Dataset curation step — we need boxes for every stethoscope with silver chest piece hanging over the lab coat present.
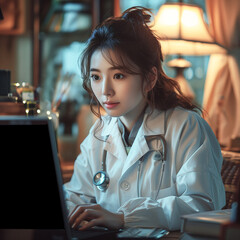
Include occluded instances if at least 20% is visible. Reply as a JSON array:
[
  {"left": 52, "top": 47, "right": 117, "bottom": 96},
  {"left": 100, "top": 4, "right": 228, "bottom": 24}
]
[{"left": 93, "top": 135, "right": 166, "bottom": 199}]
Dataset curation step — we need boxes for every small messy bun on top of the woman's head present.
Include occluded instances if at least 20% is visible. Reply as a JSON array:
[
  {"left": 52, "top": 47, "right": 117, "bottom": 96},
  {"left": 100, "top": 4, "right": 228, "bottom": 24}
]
[{"left": 122, "top": 7, "right": 152, "bottom": 25}]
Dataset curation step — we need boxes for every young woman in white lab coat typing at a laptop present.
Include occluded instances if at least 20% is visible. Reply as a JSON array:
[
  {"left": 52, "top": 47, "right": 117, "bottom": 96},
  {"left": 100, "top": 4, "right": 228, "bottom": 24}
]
[{"left": 64, "top": 7, "right": 225, "bottom": 230}]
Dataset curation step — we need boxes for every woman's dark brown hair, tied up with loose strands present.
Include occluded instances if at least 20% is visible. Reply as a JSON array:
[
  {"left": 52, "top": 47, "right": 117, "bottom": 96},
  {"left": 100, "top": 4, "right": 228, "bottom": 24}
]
[{"left": 81, "top": 7, "right": 201, "bottom": 117}]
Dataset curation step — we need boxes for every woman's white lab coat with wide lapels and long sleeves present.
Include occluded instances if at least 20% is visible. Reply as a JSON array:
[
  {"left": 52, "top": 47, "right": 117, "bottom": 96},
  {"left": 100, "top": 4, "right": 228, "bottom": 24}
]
[{"left": 64, "top": 108, "right": 225, "bottom": 230}]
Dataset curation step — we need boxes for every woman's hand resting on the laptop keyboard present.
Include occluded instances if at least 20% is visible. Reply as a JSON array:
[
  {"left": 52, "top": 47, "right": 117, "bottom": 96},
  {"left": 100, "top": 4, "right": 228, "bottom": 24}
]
[{"left": 69, "top": 204, "right": 124, "bottom": 230}]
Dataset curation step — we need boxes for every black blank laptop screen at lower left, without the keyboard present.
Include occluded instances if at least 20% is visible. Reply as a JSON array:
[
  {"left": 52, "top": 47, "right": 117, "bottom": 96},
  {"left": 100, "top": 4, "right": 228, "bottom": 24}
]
[{"left": 0, "top": 118, "right": 64, "bottom": 229}]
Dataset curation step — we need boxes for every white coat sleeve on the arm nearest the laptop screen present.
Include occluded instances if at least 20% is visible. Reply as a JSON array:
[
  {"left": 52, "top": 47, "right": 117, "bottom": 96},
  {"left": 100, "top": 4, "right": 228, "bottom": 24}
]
[{"left": 63, "top": 137, "right": 96, "bottom": 212}]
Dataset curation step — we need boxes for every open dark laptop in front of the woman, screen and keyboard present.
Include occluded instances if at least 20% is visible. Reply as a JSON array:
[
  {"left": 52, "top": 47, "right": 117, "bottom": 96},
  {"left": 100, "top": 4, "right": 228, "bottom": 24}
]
[{"left": 0, "top": 116, "right": 116, "bottom": 240}]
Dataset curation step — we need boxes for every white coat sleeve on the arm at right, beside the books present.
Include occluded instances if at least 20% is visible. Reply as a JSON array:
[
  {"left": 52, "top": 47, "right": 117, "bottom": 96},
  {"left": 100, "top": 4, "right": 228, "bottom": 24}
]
[{"left": 118, "top": 112, "right": 225, "bottom": 230}]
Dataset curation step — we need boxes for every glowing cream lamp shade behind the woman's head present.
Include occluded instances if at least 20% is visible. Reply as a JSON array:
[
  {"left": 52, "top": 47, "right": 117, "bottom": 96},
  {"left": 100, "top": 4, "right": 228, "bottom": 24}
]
[{"left": 152, "top": 3, "right": 226, "bottom": 55}]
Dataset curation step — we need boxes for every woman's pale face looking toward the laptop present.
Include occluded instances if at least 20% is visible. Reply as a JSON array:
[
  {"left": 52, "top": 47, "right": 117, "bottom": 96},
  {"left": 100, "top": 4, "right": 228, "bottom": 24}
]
[{"left": 90, "top": 50, "right": 146, "bottom": 130}]
